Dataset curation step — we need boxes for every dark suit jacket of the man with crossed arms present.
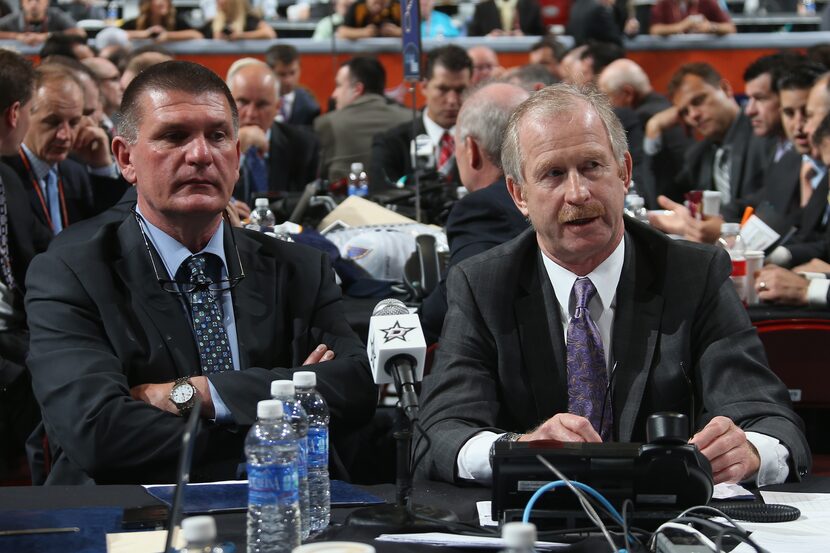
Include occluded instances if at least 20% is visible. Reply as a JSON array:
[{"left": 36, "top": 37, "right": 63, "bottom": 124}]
[{"left": 26, "top": 213, "right": 377, "bottom": 484}]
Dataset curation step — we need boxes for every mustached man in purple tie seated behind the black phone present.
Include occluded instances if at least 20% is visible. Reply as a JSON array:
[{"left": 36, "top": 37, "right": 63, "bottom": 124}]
[{"left": 415, "top": 84, "right": 810, "bottom": 485}]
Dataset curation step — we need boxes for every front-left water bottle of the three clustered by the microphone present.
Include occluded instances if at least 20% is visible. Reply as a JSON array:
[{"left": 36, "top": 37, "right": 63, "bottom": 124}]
[{"left": 245, "top": 399, "right": 301, "bottom": 553}]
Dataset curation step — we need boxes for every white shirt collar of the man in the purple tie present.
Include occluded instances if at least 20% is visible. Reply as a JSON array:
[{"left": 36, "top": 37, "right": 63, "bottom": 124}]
[{"left": 542, "top": 238, "right": 625, "bottom": 316}]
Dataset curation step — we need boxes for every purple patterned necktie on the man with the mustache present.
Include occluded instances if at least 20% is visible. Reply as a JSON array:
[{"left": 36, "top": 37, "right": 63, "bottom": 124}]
[{"left": 567, "top": 278, "right": 613, "bottom": 441}]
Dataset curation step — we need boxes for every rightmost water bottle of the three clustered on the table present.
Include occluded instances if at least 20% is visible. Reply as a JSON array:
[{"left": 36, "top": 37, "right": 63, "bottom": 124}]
[{"left": 294, "top": 371, "right": 331, "bottom": 532}]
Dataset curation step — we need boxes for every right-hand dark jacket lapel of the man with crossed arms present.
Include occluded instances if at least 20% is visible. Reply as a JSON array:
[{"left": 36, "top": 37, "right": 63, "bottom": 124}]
[{"left": 229, "top": 225, "right": 278, "bottom": 369}]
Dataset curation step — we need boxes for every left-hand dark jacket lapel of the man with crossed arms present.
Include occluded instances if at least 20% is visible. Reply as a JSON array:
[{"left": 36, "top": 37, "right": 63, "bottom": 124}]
[{"left": 114, "top": 214, "right": 201, "bottom": 376}]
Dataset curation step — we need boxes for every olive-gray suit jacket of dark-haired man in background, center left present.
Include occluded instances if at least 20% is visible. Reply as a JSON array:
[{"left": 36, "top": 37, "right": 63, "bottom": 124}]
[{"left": 314, "top": 94, "right": 412, "bottom": 181}]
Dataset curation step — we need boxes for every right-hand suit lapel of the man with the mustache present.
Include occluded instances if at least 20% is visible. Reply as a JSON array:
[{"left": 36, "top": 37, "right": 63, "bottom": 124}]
[{"left": 611, "top": 232, "right": 663, "bottom": 442}]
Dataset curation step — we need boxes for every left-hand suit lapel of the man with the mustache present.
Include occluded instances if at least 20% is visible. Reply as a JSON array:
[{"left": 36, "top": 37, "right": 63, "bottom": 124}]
[{"left": 514, "top": 235, "right": 568, "bottom": 420}]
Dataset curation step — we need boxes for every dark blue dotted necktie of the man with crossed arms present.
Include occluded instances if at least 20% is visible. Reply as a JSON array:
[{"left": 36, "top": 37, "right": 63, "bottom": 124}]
[{"left": 179, "top": 254, "right": 233, "bottom": 374}]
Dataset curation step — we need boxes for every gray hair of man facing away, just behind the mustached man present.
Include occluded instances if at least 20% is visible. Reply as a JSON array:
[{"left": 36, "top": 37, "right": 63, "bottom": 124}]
[{"left": 455, "top": 82, "right": 529, "bottom": 169}]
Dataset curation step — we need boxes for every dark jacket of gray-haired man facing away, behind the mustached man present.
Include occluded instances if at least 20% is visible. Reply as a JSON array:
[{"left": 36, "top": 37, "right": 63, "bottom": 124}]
[{"left": 421, "top": 177, "right": 528, "bottom": 343}]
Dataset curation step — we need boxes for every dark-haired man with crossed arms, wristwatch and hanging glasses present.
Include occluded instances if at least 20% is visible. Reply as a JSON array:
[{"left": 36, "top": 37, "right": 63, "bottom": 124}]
[{"left": 26, "top": 61, "right": 377, "bottom": 484}]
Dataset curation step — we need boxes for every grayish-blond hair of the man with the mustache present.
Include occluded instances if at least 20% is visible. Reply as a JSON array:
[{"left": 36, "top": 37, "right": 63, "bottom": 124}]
[{"left": 501, "top": 83, "right": 628, "bottom": 185}]
